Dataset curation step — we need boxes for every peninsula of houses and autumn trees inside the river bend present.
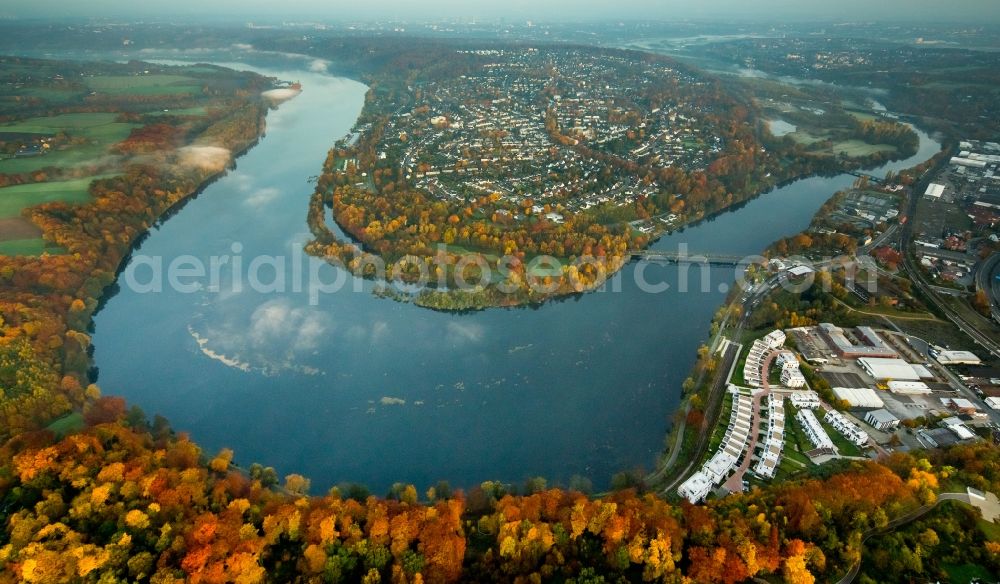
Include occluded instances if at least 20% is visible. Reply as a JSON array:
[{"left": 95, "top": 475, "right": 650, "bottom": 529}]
[{"left": 296, "top": 38, "right": 919, "bottom": 311}]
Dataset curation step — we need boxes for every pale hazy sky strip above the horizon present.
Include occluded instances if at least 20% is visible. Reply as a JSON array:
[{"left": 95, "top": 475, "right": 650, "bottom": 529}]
[{"left": 7, "top": 0, "right": 1000, "bottom": 23}]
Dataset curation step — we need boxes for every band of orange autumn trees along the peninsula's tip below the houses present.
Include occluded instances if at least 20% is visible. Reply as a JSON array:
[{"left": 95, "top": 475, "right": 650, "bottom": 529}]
[{"left": 306, "top": 151, "right": 642, "bottom": 310}]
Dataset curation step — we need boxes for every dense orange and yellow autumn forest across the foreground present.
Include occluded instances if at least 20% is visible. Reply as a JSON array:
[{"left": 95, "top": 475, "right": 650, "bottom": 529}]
[{"left": 0, "top": 398, "right": 984, "bottom": 583}]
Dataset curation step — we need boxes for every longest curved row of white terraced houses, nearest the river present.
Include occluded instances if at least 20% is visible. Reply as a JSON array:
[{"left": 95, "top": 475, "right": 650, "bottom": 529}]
[{"left": 677, "top": 385, "right": 756, "bottom": 503}]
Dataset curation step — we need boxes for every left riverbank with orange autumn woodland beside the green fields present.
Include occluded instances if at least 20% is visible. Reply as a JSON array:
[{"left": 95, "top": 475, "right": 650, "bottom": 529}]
[{"left": 0, "top": 60, "right": 282, "bottom": 436}]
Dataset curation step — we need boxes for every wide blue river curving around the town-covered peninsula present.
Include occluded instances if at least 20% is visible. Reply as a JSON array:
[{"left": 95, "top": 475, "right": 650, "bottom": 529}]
[{"left": 93, "top": 58, "right": 940, "bottom": 492}]
